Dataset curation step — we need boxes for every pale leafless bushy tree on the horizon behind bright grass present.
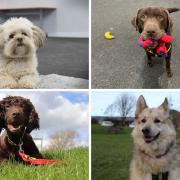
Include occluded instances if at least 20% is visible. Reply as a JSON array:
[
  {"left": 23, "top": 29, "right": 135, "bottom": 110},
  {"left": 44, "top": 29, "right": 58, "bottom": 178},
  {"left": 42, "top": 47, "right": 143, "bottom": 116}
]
[{"left": 48, "top": 130, "right": 78, "bottom": 150}]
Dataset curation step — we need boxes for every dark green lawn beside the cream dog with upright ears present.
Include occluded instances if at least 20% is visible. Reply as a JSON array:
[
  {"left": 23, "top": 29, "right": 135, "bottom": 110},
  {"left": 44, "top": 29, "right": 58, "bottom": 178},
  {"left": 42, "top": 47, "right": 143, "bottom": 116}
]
[{"left": 92, "top": 125, "right": 180, "bottom": 180}]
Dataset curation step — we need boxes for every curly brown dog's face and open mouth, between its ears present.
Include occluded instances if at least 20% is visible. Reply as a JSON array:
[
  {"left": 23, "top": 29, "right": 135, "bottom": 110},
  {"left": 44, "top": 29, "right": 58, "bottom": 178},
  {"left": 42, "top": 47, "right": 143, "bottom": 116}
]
[{"left": 5, "top": 106, "right": 28, "bottom": 134}]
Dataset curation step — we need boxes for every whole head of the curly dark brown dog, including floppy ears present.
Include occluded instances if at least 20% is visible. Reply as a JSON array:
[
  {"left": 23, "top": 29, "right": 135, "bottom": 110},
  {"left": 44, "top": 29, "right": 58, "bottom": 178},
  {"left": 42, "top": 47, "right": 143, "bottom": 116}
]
[{"left": 0, "top": 96, "right": 39, "bottom": 134}]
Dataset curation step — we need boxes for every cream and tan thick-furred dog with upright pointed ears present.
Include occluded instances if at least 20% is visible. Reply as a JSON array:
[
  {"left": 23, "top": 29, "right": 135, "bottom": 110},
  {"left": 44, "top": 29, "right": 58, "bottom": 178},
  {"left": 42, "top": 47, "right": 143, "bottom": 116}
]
[{"left": 130, "top": 96, "right": 180, "bottom": 180}]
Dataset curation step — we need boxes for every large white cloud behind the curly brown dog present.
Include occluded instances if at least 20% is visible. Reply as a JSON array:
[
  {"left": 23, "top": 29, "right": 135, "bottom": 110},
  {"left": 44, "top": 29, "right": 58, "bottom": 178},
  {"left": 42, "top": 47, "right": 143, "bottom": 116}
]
[{"left": 0, "top": 91, "right": 89, "bottom": 147}]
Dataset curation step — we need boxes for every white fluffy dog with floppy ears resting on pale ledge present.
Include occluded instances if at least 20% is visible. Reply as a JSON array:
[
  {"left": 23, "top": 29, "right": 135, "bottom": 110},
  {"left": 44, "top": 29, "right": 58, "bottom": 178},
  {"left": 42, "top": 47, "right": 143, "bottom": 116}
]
[{"left": 0, "top": 17, "right": 45, "bottom": 88}]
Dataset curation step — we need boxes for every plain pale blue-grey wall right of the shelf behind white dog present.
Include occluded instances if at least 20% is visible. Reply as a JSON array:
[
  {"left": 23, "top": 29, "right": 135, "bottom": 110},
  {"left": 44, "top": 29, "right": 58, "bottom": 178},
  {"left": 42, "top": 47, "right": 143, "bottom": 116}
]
[{"left": 44, "top": 0, "right": 89, "bottom": 37}]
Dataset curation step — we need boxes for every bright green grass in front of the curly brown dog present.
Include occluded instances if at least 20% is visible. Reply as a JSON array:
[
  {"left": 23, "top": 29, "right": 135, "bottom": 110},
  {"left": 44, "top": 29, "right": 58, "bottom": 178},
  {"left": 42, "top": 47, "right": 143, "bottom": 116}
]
[{"left": 0, "top": 148, "right": 88, "bottom": 180}]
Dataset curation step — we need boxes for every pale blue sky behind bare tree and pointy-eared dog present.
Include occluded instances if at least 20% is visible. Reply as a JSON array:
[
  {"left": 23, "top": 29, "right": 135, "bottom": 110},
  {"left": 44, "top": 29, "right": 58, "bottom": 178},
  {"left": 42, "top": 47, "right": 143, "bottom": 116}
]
[{"left": 91, "top": 90, "right": 180, "bottom": 116}]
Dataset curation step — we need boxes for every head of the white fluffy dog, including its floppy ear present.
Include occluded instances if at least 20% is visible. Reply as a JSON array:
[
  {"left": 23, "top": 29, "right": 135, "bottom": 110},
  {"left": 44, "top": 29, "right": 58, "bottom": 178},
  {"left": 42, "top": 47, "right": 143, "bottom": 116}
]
[{"left": 0, "top": 18, "right": 45, "bottom": 58}]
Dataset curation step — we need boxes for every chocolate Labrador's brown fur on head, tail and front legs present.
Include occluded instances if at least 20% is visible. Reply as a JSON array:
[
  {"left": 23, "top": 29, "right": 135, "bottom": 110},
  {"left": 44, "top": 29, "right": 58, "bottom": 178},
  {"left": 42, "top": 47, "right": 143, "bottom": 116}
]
[{"left": 131, "top": 7, "right": 179, "bottom": 77}]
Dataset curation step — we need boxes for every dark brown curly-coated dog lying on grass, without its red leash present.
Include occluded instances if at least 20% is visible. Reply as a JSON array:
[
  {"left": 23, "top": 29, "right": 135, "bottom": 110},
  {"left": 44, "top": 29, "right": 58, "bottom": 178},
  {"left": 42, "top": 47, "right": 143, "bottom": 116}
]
[{"left": 0, "top": 96, "right": 42, "bottom": 162}]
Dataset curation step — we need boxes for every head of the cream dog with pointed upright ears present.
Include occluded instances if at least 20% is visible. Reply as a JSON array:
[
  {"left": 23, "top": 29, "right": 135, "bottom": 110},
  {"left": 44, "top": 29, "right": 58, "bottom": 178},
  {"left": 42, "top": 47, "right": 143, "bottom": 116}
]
[{"left": 132, "top": 96, "right": 176, "bottom": 144}]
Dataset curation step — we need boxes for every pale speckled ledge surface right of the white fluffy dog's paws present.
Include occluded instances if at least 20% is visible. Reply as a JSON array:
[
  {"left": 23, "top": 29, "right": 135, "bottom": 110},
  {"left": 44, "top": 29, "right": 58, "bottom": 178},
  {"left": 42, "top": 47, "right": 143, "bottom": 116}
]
[{"left": 37, "top": 74, "right": 89, "bottom": 89}]
